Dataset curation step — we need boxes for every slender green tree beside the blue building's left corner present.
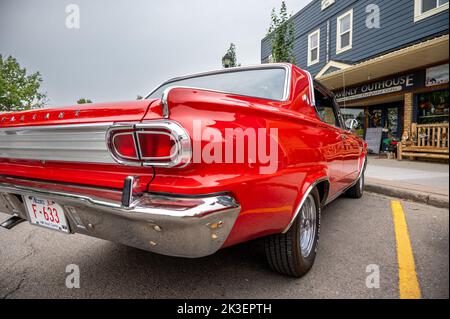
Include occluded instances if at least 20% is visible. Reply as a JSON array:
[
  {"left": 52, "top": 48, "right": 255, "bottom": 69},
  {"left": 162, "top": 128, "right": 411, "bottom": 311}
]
[{"left": 267, "top": 1, "right": 295, "bottom": 64}]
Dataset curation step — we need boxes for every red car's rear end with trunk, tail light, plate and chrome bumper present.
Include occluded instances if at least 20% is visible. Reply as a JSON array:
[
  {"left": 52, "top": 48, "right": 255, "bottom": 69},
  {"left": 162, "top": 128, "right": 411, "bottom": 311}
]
[{"left": 0, "top": 100, "right": 240, "bottom": 257}]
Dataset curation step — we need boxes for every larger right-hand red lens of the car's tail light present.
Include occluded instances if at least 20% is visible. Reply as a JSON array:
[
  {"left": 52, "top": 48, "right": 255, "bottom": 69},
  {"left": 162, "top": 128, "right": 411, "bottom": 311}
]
[{"left": 137, "top": 131, "right": 176, "bottom": 160}]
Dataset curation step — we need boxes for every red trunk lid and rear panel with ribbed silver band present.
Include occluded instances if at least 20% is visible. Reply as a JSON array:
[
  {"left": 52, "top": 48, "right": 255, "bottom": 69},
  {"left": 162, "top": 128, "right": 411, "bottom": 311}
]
[{"left": 0, "top": 100, "right": 162, "bottom": 189}]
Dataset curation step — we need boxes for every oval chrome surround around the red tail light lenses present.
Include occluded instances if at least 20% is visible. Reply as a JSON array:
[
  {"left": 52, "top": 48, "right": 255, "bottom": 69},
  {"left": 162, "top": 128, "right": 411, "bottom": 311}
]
[{"left": 106, "top": 120, "right": 192, "bottom": 168}]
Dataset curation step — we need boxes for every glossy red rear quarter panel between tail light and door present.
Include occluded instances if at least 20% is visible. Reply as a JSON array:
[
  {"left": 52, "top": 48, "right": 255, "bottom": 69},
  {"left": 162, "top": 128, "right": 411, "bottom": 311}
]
[{"left": 149, "top": 89, "right": 337, "bottom": 246}]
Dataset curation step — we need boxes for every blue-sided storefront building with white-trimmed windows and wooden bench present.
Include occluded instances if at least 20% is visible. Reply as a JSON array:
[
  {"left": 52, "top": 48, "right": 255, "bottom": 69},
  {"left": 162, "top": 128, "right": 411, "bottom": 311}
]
[{"left": 261, "top": 0, "right": 449, "bottom": 158}]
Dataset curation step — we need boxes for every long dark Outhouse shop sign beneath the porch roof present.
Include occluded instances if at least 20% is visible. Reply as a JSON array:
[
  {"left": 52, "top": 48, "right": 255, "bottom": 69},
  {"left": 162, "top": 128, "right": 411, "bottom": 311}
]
[{"left": 336, "top": 73, "right": 416, "bottom": 102}]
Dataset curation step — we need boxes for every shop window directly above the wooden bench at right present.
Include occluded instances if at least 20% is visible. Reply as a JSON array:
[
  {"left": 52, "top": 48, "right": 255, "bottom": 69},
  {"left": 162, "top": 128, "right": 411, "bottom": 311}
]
[{"left": 417, "top": 90, "right": 449, "bottom": 124}]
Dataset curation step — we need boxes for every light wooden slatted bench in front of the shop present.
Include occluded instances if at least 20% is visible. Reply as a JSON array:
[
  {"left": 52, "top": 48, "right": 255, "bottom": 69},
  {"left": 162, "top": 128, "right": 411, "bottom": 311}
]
[{"left": 397, "top": 123, "right": 449, "bottom": 161}]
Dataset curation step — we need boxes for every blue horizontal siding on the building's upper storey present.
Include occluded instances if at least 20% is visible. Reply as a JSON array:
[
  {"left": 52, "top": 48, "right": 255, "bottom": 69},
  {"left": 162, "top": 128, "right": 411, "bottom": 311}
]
[{"left": 261, "top": 0, "right": 449, "bottom": 75}]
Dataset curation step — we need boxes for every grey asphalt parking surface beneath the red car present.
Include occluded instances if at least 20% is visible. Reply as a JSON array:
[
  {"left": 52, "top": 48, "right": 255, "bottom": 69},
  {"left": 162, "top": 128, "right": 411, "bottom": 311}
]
[{"left": 0, "top": 193, "right": 449, "bottom": 298}]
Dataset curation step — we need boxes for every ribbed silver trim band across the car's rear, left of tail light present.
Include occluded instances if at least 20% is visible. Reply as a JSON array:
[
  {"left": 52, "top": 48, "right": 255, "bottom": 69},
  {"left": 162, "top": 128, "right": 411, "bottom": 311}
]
[{"left": 0, "top": 123, "right": 115, "bottom": 164}]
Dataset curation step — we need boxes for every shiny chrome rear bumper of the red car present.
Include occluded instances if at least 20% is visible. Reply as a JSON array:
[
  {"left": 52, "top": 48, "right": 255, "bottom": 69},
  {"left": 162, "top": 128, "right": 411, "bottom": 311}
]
[{"left": 0, "top": 176, "right": 240, "bottom": 258}]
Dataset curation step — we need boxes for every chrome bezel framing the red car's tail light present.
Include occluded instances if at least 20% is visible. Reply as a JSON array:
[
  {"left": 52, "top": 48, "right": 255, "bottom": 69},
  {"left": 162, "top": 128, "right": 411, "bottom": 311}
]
[{"left": 106, "top": 120, "right": 192, "bottom": 168}]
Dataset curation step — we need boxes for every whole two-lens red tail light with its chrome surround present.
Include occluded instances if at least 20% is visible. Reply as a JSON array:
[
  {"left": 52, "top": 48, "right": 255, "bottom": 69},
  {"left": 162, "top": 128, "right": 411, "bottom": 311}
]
[{"left": 107, "top": 120, "right": 192, "bottom": 167}]
